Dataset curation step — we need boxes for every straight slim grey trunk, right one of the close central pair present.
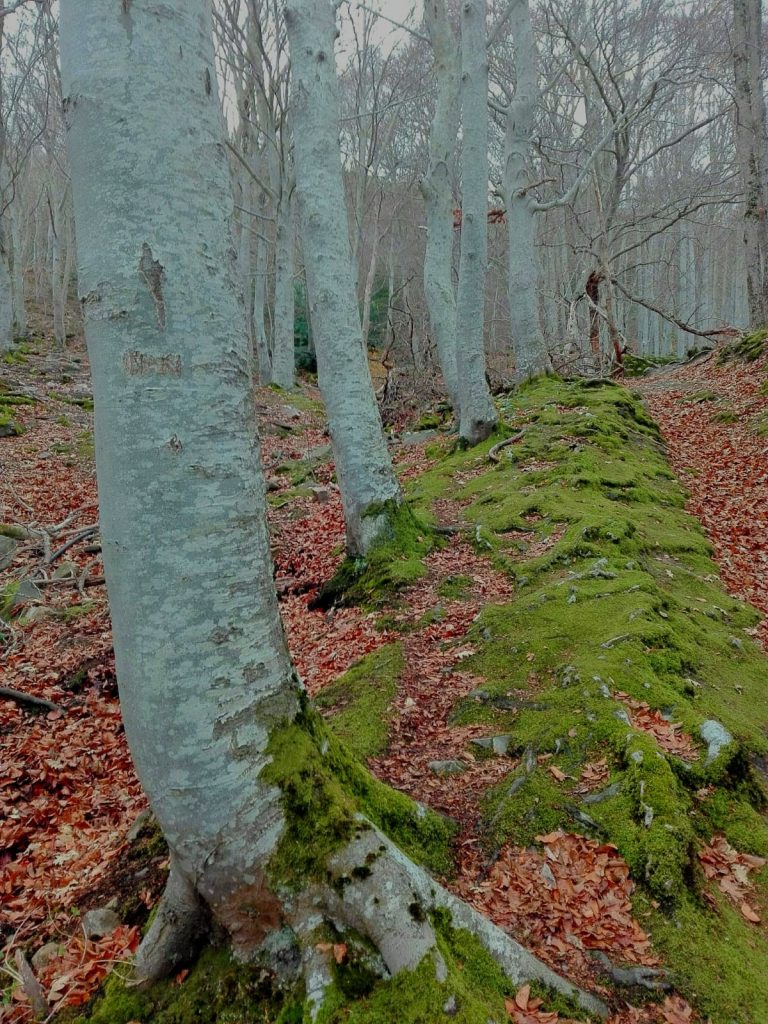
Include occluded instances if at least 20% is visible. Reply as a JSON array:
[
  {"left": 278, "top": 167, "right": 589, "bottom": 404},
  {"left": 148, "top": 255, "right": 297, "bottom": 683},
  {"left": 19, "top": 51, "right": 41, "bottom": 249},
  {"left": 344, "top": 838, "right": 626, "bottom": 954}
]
[{"left": 456, "top": 0, "right": 499, "bottom": 444}]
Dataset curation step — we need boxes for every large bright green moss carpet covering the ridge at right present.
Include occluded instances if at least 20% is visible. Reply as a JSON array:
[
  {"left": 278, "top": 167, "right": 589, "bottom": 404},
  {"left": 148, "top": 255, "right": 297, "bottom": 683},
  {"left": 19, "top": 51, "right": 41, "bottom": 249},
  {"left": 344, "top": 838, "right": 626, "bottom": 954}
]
[{"left": 399, "top": 379, "right": 768, "bottom": 905}]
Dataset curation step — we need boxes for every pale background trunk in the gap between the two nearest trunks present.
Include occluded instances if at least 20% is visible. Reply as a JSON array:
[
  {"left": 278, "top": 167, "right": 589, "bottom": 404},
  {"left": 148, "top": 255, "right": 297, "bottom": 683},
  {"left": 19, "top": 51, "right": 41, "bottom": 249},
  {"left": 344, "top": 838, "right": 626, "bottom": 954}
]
[{"left": 271, "top": 180, "right": 296, "bottom": 388}]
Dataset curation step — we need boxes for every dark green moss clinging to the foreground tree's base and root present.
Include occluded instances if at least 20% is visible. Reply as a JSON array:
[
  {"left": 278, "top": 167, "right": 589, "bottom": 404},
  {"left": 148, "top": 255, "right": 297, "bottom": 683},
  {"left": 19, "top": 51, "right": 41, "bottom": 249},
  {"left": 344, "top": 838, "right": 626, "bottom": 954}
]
[{"left": 263, "top": 709, "right": 455, "bottom": 888}]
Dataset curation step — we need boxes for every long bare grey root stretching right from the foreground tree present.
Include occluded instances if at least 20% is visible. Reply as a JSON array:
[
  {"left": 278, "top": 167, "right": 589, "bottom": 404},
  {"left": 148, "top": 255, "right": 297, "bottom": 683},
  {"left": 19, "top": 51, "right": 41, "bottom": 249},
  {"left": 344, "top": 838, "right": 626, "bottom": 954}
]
[{"left": 328, "top": 819, "right": 608, "bottom": 1017}]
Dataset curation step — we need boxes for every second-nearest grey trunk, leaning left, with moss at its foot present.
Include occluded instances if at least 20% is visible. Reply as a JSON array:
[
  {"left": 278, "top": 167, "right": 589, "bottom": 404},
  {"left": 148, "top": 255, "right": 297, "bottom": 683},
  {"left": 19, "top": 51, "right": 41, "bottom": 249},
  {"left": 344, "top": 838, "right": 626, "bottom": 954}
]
[{"left": 286, "top": 0, "right": 401, "bottom": 555}]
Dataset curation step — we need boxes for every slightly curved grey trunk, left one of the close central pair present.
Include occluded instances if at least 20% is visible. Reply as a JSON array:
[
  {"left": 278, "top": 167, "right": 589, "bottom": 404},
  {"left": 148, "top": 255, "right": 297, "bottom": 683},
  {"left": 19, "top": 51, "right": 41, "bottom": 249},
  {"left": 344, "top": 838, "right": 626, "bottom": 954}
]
[{"left": 420, "top": 0, "right": 461, "bottom": 412}]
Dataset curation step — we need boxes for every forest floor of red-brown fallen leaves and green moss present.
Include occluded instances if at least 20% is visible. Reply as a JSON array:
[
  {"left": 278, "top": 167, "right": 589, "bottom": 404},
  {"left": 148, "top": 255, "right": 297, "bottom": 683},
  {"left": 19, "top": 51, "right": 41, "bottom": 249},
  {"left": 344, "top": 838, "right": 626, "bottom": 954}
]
[{"left": 0, "top": 327, "right": 768, "bottom": 1024}]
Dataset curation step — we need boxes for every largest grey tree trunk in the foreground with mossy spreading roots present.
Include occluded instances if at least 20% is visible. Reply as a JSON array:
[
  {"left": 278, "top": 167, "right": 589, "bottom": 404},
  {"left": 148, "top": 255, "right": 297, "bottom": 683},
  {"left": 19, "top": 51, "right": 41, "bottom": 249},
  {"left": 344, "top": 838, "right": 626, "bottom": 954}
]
[{"left": 61, "top": 0, "right": 599, "bottom": 1011}]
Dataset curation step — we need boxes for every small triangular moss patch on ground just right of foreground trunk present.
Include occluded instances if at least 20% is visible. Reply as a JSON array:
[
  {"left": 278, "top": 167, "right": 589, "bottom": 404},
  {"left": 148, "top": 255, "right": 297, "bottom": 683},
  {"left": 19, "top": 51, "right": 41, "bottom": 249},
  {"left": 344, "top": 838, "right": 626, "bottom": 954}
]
[{"left": 314, "top": 643, "right": 404, "bottom": 761}]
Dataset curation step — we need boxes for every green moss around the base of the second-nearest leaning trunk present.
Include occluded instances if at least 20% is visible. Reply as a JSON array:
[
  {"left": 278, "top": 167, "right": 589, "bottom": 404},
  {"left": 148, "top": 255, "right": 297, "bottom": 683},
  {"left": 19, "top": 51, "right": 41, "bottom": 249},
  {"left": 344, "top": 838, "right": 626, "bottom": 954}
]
[{"left": 310, "top": 502, "right": 439, "bottom": 608}]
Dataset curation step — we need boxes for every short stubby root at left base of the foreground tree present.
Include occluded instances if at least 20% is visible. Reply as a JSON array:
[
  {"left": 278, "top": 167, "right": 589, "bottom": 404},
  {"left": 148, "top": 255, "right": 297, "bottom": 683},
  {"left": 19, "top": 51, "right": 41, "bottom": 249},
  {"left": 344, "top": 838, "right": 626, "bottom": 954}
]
[{"left": 134, "top": 858, "right": 209, "bottom": 988}]
